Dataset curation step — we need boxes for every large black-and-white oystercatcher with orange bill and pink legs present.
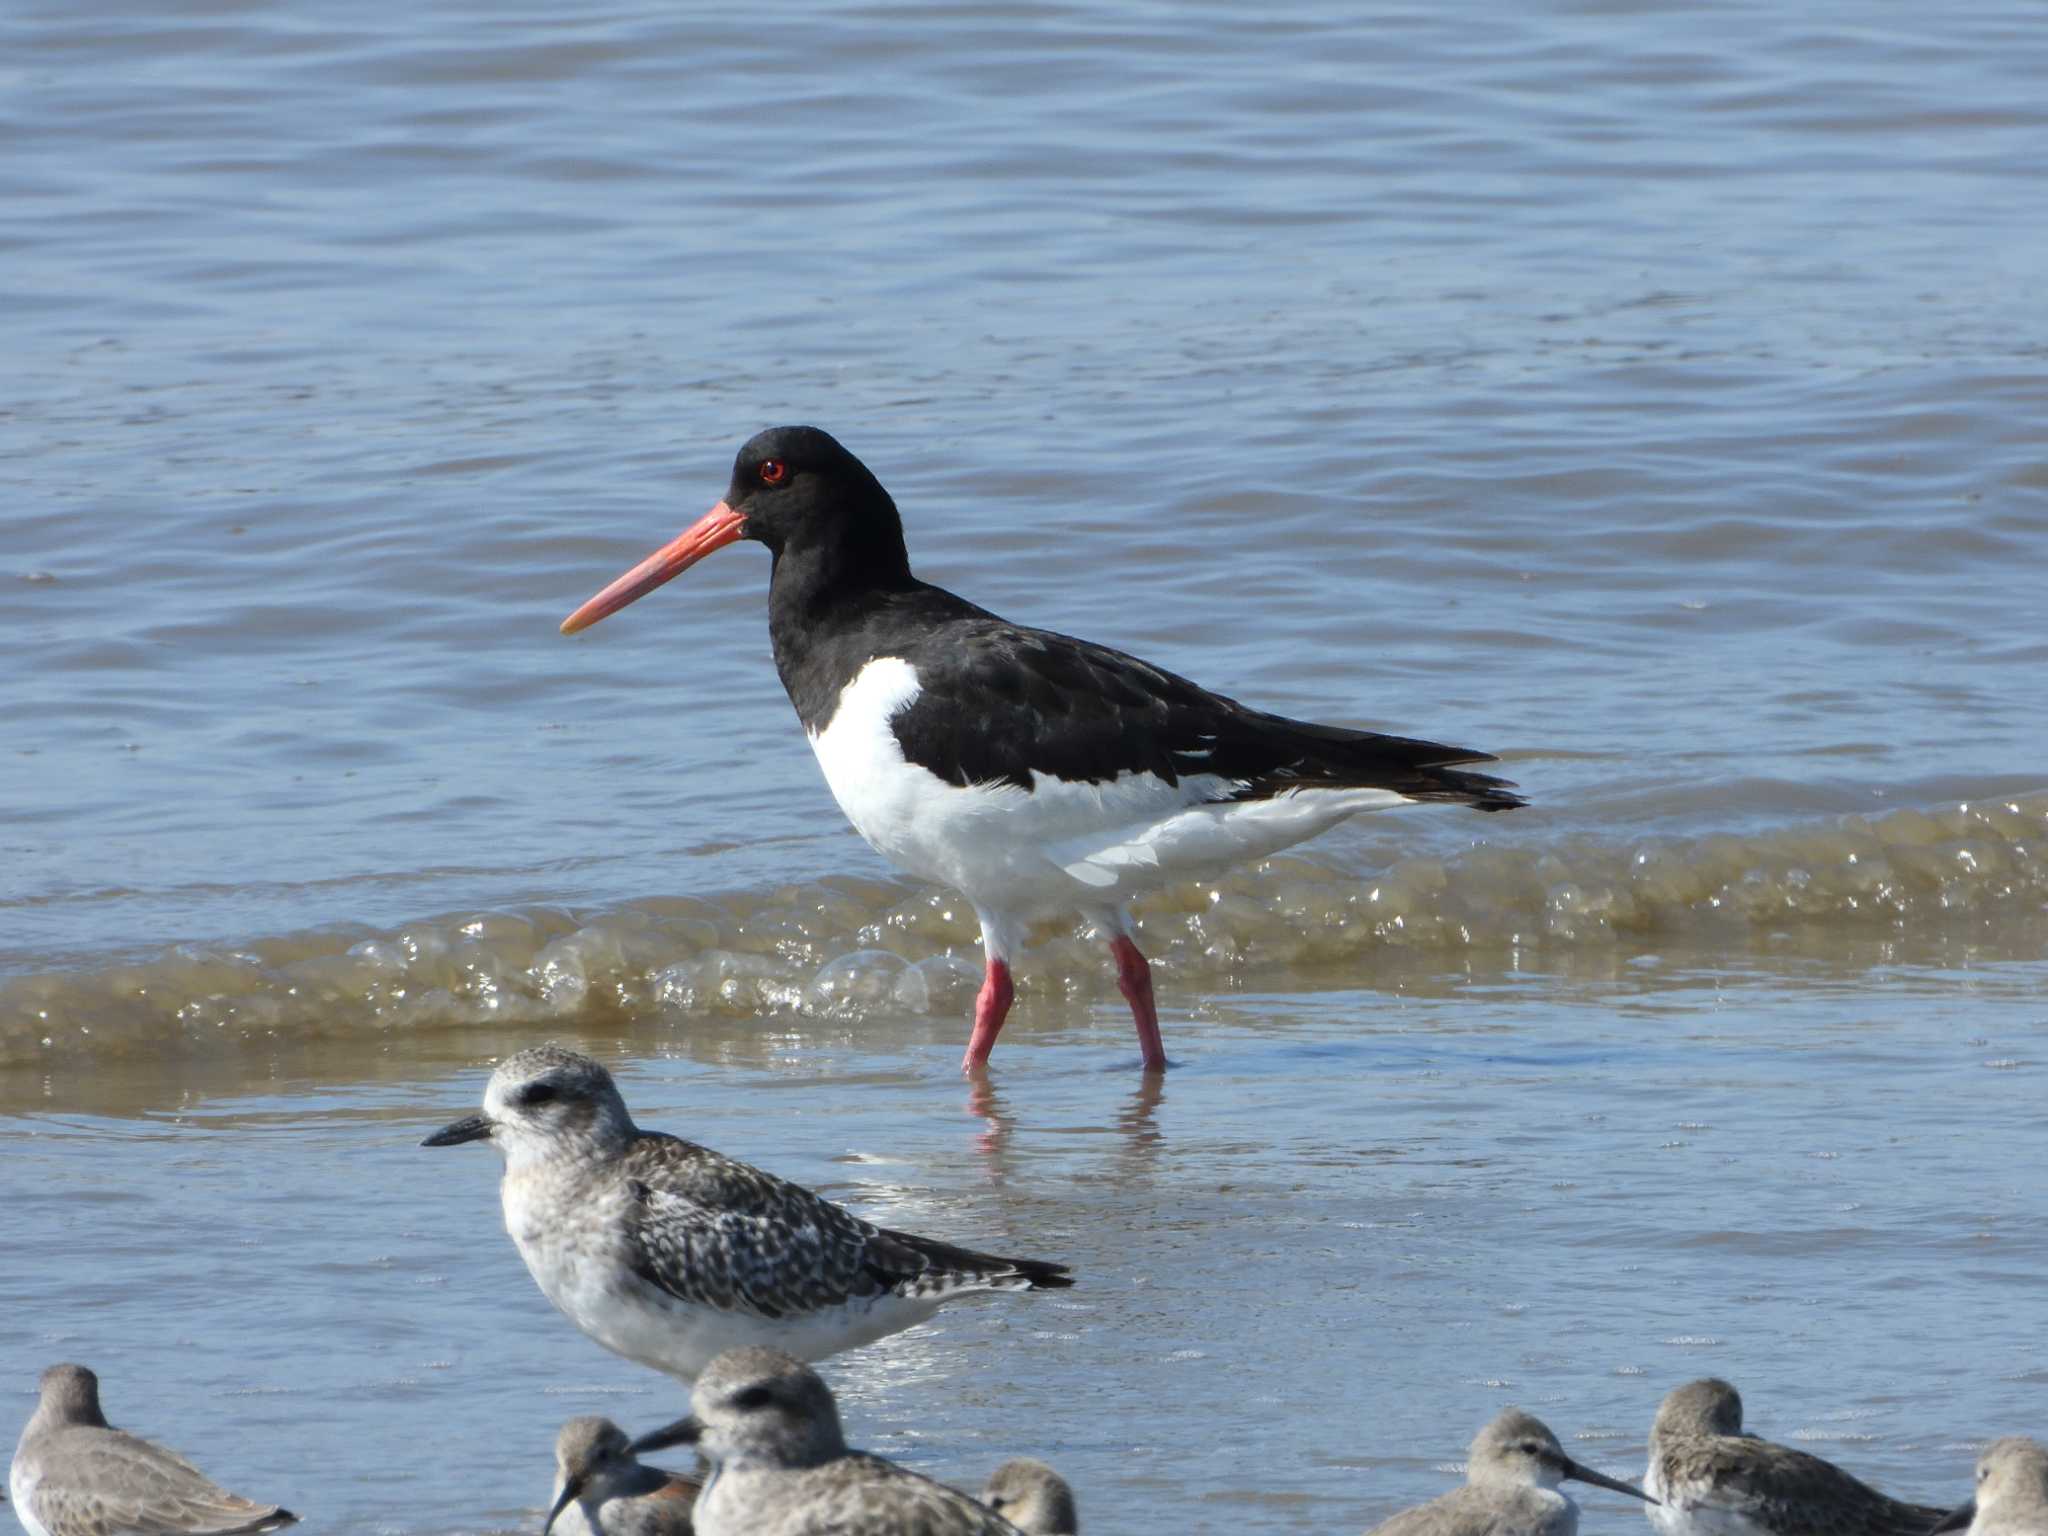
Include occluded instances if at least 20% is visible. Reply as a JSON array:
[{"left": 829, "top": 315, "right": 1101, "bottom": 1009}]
[{"left": 561, "top": 426, "right": 1526, "bottom": 1073}]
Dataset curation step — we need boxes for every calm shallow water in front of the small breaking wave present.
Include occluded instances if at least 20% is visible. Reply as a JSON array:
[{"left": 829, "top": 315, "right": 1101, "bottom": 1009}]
[{"left": 0, "top": 974, "right": 2048, "bottom": 1532}]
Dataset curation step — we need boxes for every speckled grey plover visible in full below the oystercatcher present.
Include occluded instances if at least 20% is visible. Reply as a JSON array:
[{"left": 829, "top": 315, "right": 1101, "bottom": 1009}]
[{"left": 424, "top": 1044, "right": 1073, "bottom": 1380}]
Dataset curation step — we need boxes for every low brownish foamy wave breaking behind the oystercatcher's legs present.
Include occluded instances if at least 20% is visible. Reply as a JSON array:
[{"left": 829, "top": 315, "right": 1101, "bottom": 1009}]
[{"left": 0, "top": 793, "right": 2048, "bottom": 1065}]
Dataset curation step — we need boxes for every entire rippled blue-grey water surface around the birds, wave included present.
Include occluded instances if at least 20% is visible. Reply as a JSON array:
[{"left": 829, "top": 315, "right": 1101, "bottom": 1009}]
[{"left": 0, "top": 0, "right": 2048, "bottom": 1534}]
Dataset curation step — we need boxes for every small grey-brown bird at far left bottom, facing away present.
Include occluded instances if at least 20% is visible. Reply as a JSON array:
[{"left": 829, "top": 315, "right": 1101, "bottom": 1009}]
[{"left": 8, "top": 1366, "right": 299, "bottom": 1536}]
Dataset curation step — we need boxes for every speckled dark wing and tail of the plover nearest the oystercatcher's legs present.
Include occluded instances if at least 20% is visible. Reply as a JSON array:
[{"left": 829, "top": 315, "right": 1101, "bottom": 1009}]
[{"left": 621, "top": 1133, "right": 1073, "bottom": 1317}]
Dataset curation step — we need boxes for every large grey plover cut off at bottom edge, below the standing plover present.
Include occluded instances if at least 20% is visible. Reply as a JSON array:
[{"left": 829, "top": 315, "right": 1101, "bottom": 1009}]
[{"left": 633, "top": 1348, "right": 1020, "bottom": 1536}]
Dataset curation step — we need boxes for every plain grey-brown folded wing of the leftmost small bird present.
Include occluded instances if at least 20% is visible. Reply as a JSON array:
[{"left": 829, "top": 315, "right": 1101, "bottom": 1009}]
[{"left": 35, "top": 1425, "right": 297, "bottom": 1536}]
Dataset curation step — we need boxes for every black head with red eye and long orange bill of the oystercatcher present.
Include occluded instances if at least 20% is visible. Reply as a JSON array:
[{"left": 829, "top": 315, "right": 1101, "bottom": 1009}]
[{"left": 561, "top": 426, "right": 909, "bottom": 635}]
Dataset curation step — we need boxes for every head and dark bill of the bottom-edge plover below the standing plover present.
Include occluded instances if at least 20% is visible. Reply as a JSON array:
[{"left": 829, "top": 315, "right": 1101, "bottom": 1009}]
[{"left": 633, "top": 1346, "right": 846, "bottom": 1468}]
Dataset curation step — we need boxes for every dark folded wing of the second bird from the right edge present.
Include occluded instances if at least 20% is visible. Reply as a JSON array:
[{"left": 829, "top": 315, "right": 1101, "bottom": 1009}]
[{"left": 1659, "top": 1436, "right": 1948, "bottom": 1536}]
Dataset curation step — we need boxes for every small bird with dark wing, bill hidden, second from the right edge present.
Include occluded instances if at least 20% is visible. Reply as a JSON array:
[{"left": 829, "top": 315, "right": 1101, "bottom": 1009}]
[{"left": 1642, "top": 1376, "right": 1948, "bottom": 1536}]
